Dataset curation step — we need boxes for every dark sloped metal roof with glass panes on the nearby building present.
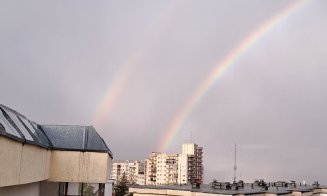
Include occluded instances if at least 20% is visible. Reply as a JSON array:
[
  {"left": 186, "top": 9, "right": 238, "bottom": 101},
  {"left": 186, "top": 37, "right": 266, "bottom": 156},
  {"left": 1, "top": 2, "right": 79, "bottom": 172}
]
[{"left": 0, "top": 104, "right": 112, "bottom": 157}]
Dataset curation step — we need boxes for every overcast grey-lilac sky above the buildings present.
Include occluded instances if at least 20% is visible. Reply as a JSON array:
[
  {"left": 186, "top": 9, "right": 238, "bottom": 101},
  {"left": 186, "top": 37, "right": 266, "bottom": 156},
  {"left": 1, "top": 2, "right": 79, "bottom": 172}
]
[{"left": 0, "top": 0, "right": 327, "bottom": 184}]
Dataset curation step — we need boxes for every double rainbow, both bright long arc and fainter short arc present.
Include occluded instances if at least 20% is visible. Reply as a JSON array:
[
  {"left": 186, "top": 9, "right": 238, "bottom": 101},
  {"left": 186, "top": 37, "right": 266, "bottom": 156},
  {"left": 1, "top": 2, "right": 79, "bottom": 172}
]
[{"left": 93, "top": 0, "right": 312, "bottom": 152}]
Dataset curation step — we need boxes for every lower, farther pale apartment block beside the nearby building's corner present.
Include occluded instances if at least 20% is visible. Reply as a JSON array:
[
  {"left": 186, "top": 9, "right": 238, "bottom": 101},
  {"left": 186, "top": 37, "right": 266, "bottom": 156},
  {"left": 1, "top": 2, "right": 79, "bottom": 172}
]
[{"left": 111, "top": 160, "right": 145, "bottom": 185}]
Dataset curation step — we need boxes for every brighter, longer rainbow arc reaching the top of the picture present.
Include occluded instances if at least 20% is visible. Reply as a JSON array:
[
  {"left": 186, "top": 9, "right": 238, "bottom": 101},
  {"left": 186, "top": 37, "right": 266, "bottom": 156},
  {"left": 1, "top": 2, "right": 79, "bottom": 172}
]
[{"left": 159, "top": 0, "right": 308, "bottom": 152}]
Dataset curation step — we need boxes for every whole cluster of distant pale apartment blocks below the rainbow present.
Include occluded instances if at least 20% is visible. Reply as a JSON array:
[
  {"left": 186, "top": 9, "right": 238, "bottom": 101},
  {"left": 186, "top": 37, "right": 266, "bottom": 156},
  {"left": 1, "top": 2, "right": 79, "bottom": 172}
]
[{"left": 110, "top": 143, "right": 204, "bottom": 185}]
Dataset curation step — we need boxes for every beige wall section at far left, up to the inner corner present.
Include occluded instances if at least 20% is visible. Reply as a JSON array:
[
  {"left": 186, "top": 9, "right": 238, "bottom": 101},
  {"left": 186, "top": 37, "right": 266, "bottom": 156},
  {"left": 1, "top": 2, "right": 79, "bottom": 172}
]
[{"left": 0, "top": 136, "right": 51, "bottom": 187}]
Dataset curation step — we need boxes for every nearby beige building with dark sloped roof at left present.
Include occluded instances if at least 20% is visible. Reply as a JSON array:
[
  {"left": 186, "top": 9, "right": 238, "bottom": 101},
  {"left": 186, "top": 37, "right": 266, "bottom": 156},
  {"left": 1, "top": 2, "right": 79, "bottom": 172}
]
[{"left": 0, "top": 105, "right": 113, "bottom": 196}]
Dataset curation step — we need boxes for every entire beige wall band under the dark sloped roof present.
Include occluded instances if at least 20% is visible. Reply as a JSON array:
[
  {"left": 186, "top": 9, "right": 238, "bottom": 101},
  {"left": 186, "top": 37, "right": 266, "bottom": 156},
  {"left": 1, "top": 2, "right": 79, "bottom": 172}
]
[{"left": 0, "top": 136, "right": 112, "bottom": 187}]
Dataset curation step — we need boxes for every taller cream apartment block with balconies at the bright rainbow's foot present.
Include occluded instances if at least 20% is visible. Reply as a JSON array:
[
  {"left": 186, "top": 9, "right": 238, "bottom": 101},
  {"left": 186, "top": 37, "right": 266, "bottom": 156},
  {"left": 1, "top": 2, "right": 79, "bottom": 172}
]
[{"left": 145, "top": 143, "right": 203, "bottom": 185}]
